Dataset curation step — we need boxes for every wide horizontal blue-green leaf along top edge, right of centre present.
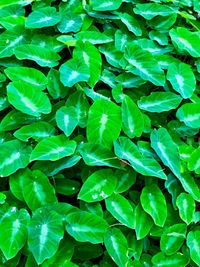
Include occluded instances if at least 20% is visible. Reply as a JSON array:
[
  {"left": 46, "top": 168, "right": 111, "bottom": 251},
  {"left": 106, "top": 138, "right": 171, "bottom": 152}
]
[{"left": 134, "top": 3, "right": 177, "bottom": 20}]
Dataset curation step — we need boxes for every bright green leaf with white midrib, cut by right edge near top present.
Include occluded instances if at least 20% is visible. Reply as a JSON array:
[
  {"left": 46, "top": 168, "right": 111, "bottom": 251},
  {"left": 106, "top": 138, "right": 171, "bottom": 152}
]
[{"left": 169, "top": 27, "right": 200, "bottom": 57}]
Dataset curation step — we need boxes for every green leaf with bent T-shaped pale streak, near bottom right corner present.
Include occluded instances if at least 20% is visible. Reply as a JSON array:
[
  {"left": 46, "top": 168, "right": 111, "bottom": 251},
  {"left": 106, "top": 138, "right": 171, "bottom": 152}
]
[{"left": 160, "top": 223, "right": 187, "bottom": 255}]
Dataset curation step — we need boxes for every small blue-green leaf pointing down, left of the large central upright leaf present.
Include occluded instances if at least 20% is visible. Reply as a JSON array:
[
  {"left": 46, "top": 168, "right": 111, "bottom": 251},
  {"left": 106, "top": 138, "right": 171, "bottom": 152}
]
[{"left": 56, "top": 106, "right": 78, "bottom": 136}]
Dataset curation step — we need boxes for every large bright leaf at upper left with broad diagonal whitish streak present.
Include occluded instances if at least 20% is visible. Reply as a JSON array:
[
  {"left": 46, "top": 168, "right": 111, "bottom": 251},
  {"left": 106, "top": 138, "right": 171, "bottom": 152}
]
[{"left": 7, "top": 81, "right": 51, "bottom": 117}]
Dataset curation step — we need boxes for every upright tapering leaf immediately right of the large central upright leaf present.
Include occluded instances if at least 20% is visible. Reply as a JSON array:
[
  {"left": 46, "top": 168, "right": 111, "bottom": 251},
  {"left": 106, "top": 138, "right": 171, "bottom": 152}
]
[{"left": 122, "top": 96, "right": 144, "bottom": 138}]
